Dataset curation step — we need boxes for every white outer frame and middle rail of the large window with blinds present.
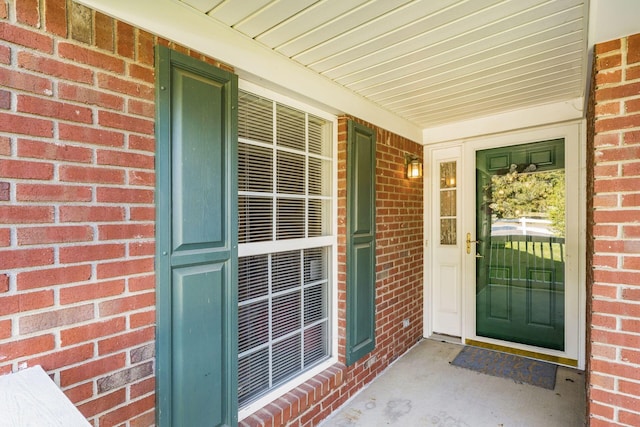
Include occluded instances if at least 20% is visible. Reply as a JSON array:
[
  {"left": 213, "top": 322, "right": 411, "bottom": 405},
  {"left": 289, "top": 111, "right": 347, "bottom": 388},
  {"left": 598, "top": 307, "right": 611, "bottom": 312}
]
[{"left": 238, "top": 79, "right": 338, "bottom": 421}]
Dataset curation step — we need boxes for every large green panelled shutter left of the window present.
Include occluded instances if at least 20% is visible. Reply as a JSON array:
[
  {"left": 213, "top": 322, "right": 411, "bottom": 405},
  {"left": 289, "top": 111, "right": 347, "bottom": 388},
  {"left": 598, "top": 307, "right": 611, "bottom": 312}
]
[{"left": 156, "top": 47, "right": 238, "bottom": 427}]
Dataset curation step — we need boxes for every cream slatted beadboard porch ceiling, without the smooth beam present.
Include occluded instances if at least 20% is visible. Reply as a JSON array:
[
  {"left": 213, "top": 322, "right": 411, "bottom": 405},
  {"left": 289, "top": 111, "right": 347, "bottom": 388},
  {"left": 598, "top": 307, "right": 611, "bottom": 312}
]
[{"left": 179, "top": 0, "right": 588, "bottom": 129}]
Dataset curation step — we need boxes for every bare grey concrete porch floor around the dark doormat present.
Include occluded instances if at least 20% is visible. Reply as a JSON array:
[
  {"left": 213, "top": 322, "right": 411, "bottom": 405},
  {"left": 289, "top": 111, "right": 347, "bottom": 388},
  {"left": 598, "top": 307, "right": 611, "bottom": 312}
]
[{"left": 321, "top": 339, "right": 586, "bottom": 427}]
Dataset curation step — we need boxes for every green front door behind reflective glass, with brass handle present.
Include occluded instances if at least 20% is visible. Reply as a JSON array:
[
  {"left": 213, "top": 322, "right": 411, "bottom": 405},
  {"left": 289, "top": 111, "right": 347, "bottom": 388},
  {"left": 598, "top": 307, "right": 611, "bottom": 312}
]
[{"left": 476, "top": 139, "right": 565, "bottom": 351}]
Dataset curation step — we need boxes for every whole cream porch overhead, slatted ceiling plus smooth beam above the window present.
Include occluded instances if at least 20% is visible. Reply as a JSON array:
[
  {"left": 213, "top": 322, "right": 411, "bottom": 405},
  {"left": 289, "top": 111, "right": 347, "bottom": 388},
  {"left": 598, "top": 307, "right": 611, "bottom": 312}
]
[{"left": 81, "top": 0, "right": 588, "bottom": 141}]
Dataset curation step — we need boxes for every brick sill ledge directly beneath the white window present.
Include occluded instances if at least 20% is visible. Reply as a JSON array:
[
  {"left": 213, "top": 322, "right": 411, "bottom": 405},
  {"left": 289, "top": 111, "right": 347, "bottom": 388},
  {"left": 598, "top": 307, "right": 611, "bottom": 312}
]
[{"left": 238, "top": 363, "right": 347, "bottom": 427}]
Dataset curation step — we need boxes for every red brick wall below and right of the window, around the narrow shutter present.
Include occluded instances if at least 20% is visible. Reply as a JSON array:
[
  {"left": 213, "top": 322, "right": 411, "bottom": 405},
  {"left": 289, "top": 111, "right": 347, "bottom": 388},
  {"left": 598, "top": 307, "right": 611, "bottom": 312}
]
[{"left": 241, "top": 117, "right": 424, "bottom": 427}]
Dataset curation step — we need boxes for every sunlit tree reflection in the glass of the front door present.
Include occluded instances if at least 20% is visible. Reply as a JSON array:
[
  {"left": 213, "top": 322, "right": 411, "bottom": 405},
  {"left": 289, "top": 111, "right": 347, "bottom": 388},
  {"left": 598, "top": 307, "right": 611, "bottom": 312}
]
[{"left": 487, "top": 165, "right": 565, "bottom": 236}]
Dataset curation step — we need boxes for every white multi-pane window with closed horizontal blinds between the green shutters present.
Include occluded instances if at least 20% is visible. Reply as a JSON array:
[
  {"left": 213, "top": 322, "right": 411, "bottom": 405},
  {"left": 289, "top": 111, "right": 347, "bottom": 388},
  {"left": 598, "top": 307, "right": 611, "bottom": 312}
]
[{"left": 238, "top": 84, "right": 336, "bottom": 415}]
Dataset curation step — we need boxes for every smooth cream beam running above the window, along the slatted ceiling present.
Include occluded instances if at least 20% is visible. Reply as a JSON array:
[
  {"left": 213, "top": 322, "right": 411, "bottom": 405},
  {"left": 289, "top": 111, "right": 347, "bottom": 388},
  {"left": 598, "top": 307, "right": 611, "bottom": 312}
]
[{"left": 78, "top": 0, "right": 422, "bottom": 142}]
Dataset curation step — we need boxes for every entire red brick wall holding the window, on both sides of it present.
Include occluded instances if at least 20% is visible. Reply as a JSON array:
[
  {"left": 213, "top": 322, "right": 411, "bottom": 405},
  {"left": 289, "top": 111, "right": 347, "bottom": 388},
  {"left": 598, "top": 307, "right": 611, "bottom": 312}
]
[{"left": 0, "top": 0, "right": 423, "bottom": 427}]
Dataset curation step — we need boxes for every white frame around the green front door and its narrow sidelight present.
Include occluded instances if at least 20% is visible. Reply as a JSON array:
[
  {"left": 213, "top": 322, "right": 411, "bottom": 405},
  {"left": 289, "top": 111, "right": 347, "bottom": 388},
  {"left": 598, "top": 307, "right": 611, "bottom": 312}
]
[{"left": 424, "top": 121, "right": 586, "bottom": 369}]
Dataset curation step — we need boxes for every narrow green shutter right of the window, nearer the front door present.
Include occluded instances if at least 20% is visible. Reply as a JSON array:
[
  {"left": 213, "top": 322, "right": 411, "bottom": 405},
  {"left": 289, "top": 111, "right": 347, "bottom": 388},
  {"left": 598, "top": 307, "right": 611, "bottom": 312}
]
[{"left": 347, "top": 121, "right": 376, "bottom": 365}]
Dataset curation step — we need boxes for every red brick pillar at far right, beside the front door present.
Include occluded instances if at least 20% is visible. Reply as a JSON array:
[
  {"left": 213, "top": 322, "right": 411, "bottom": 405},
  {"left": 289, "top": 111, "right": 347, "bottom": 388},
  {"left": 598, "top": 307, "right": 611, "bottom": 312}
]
[{"left": 588, "top": 34, "right": 640, "bottom": 426}]
